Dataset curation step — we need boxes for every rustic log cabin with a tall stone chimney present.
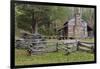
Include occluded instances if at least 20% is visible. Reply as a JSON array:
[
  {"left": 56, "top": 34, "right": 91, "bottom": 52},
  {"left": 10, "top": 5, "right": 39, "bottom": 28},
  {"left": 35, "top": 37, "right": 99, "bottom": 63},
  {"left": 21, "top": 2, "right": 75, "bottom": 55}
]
[{"left": 58, "top": 8, "right": 93, "bottom": 39}]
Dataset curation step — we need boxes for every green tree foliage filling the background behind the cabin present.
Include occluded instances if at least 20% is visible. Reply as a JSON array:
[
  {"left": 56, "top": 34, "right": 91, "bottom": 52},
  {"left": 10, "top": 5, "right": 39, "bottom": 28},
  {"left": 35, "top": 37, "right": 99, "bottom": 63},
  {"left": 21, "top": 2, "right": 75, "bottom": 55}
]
[{"left": 15, "top": 4, "right": 93, "bottom": 36}]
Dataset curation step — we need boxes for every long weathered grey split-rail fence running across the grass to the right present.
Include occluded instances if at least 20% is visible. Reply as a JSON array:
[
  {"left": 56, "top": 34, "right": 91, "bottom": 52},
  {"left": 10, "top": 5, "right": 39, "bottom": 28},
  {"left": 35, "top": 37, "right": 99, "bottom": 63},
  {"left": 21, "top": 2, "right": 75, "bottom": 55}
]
[{"left": 16, "top": 40, "right": 94, "bottom": 54}]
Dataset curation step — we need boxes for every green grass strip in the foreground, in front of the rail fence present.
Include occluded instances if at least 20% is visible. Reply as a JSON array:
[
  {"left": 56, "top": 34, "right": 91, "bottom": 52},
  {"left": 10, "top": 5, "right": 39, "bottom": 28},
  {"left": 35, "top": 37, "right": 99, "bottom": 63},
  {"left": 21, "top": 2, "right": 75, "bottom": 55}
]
[{"left": 15, "top": 49, "right": 94, "bottom": 65}]
